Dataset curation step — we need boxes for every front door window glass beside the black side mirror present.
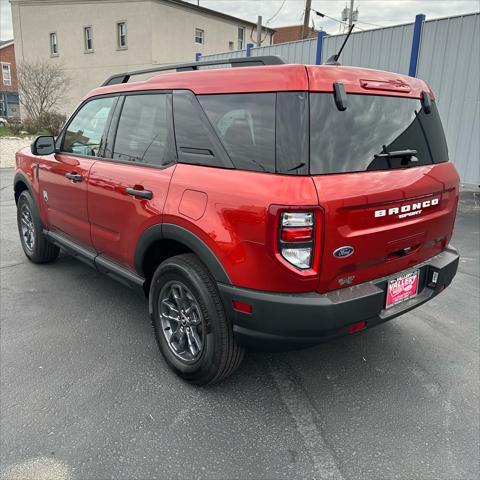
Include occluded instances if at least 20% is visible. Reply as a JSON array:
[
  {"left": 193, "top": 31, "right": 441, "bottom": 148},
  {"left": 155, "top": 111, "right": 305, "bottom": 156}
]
[{"left": 61, "top": 97, "right": 116, "bottom": 157}]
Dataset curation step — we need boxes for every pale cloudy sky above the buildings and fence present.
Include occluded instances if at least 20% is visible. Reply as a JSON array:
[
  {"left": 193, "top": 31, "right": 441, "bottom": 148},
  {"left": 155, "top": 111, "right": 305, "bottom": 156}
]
[{"left": 0, "top": 0, "right": 480, "bottom": 40}]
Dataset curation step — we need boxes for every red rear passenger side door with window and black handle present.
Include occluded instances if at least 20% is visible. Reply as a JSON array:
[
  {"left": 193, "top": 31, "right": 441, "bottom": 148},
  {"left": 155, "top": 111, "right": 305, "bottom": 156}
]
[{"left": 88, "top": 92, "right": 176, "bottom": 266}]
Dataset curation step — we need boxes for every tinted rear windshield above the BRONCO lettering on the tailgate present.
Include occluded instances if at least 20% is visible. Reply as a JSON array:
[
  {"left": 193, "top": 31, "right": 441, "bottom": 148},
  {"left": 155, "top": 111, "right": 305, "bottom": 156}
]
[{"left": 310, "top": 93, "right": 448, "bottom": 174}]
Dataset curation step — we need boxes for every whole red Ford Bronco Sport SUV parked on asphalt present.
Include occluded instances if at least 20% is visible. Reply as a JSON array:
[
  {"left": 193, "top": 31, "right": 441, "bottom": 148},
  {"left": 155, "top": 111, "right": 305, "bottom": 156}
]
[{"left": 14, "top": 57, "right": 459, "bottom": 384}]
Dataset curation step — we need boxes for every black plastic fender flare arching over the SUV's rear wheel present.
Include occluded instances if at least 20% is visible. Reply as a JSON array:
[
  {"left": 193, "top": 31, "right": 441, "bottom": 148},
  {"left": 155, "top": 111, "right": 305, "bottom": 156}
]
[{"left": 134, "top": 223, "right": 232, "bottom": 285}]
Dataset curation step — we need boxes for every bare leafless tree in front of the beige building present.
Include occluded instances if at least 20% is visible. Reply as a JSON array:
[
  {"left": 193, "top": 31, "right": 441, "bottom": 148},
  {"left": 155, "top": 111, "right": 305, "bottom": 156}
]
[{"left": 17, "top": 61, "right": 70, "bottom": 120}]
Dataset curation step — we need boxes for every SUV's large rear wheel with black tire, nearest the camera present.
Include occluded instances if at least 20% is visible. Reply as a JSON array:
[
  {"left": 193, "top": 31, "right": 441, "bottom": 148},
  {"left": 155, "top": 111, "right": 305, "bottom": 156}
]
[{"left": 149, "top": 254, "right": 244, "bottom": 385}]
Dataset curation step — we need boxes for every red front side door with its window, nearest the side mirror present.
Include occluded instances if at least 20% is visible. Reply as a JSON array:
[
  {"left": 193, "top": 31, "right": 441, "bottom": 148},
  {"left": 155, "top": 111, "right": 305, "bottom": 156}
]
[{"left": 39, "top": 97, "right": 116, "bottom": 247}]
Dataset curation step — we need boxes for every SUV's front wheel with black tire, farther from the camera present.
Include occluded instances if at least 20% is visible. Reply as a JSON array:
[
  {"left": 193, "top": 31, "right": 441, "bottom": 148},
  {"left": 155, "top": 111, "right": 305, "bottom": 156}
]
[{"left": 17, "top": 190, "right": 60, "bottom": 263}]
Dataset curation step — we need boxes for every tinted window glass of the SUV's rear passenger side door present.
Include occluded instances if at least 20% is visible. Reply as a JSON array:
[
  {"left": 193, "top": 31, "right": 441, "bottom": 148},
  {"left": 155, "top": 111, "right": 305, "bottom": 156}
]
[{"left": 112, "top": 93, "right": 173, "bottom": 166}]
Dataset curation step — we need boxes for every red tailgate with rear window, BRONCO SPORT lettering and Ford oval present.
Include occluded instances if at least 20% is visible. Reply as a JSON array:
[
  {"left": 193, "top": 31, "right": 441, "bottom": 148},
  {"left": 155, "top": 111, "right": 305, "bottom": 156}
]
[{"left": 310, "top": 93, "right": 459, "bottom": 292}]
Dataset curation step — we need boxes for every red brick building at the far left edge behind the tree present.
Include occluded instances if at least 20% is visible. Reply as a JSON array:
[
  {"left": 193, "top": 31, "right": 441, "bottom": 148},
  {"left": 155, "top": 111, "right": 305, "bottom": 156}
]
[{"left": 0, "top": 40, "right": 20, "bottom": 120}]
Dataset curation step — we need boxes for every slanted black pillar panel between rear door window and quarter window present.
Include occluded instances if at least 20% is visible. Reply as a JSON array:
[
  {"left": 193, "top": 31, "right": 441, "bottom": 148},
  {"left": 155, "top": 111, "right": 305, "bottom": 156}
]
[{"left": 173, "top": 90, "right": 233, "bottom": 168}]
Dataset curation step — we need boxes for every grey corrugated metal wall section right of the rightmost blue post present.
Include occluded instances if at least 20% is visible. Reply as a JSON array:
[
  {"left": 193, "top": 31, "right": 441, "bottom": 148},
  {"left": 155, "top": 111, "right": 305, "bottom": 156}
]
[{"left": 417, "top": 14, "right": 480, "bottom": 185}]
